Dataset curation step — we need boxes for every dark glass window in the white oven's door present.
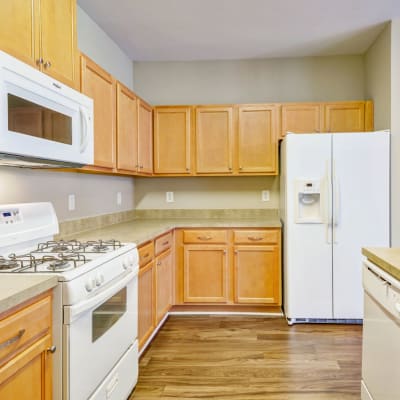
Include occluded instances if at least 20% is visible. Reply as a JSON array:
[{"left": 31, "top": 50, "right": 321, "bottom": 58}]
[{"left": 92, "top": 287, "right": 126, "bottom": 342}]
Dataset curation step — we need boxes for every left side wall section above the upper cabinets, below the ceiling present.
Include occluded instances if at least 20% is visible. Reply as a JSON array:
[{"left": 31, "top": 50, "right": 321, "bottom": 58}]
[{"left": 77, "top": 7, "right": 133, "bottom": 89}]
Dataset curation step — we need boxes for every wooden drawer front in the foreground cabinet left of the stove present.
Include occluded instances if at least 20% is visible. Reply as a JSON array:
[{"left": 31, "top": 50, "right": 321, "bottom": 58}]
[{"left": 0, "top": 296, "right": 51, "bottom": 365}]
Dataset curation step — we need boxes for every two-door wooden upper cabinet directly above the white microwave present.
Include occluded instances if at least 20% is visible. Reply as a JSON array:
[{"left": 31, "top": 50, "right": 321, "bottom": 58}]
[{"left": 0, "top": 0, "right": 78, "bottom": 87}]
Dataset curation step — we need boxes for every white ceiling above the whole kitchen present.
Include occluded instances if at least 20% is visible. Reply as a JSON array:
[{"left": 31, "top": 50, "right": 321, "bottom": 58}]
[{"left": 78, "top": 0, "right": 400, "bottom": 61}]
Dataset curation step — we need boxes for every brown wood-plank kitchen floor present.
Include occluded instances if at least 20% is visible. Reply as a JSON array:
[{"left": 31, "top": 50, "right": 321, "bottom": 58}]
[{"left": 130, "top": 316, "right": 362, "bottom": 400}]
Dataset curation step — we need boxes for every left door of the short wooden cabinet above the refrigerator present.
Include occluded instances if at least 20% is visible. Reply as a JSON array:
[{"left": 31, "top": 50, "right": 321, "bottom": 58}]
[{"left": 281, "top": 103, "right": 323, "bottom": 137}]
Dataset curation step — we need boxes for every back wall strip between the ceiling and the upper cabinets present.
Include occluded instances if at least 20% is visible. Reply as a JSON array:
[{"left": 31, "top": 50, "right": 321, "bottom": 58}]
[{"left": 134, "top": 56, "right": 364, "bottom": 104}]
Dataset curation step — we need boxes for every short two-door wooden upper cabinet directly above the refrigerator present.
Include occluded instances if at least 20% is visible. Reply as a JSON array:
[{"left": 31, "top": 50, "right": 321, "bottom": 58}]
[{"left": 281, "top": 101, "right": 374, "bottom": 137}]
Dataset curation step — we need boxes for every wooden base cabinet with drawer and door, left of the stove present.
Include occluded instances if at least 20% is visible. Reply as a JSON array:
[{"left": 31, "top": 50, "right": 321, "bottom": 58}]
[{"left": 0, "top": 292, "right": 54, "bottom": 400}]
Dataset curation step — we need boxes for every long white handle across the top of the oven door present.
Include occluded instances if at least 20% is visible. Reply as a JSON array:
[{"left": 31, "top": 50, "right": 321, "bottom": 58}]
[{"left": 64, "top": 268, "right": 138, "bottom": 325}]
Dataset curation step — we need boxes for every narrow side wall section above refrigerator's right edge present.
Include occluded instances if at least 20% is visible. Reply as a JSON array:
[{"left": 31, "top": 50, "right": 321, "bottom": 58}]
[{"left": 364, "top": 24, "right": 391, "bottom": 130}]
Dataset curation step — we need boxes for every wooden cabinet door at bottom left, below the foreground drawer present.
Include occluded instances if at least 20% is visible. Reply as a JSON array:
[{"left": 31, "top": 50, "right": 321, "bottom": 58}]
[{"left": 0, "top": 335, "right": 52, "bottom": 400}]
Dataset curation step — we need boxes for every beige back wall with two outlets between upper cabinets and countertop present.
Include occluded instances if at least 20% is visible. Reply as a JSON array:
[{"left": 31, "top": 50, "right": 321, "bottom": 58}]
[{"left": 135, "top": 176, "right": 279, "bottom": 209}]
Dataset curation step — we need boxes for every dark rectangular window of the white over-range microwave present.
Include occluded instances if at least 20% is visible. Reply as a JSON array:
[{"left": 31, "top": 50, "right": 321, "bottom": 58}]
[{"left": 8, "top": 94, "right": 72, "bottom": 144}]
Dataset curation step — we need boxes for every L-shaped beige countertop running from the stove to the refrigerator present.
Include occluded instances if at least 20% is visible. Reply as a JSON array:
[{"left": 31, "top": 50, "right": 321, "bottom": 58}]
[{"left": 64, "top": 217, "right": 281, "bottom": 245}]
